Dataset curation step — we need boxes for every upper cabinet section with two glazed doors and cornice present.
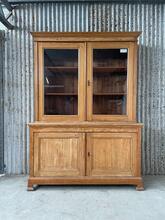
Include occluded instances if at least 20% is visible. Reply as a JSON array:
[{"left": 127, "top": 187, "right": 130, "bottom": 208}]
[{"left": 32, "top": 32, "right": 139, "bottom": 122}]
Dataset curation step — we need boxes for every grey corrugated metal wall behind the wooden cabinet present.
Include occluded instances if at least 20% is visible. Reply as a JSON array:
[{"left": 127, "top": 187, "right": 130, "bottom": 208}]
[{"left": 4, "top": 3, "right": 165, "bottom": 174}]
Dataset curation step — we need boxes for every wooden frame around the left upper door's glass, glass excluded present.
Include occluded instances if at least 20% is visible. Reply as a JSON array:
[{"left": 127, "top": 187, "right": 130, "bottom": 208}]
[{"left": 35, "top": 42, "right": 86, "bottom": 121}]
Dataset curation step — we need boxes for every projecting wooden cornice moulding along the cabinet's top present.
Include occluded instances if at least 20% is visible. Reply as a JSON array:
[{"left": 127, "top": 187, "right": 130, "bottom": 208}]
[{"left": 31, "top": 32, "right": 141, "bottom": 42}]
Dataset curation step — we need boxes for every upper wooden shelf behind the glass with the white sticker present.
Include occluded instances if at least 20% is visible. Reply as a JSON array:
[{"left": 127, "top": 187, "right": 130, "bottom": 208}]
[{"left": 93, "top": 66, "right": 127, "bottom": 73}]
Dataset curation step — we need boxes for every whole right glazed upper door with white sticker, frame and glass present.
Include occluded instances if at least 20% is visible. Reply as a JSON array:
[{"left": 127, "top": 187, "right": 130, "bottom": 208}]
[{"left": 87, "top": 42, "right": 136, "bottom": 121}]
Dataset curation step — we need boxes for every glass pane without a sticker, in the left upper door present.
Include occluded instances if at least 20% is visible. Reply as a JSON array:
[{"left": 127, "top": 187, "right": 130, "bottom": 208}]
[{"left": 44, "top": 49, "right": 78, "bottom": 115}]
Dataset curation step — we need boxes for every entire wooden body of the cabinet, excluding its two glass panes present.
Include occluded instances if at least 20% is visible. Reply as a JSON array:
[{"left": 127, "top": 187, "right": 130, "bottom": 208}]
[{"left": 28, "top": 32, "right": 143, "bottom": 190}]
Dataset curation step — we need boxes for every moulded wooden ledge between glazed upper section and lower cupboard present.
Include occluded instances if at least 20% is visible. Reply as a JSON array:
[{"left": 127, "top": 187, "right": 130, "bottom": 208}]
[{"left": 29, "top": 121, "right": 143, "bottom": 133}]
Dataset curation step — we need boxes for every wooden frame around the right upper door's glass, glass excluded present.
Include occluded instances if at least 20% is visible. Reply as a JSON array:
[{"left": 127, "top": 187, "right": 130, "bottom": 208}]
[{"left": 87, "top": 42, "right": 136, "bottom": 121}]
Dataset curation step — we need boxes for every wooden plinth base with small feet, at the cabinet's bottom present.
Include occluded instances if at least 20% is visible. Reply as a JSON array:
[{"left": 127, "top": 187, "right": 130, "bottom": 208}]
[{"left": 28, "top": 177, "right": 144, "bottom": 191}]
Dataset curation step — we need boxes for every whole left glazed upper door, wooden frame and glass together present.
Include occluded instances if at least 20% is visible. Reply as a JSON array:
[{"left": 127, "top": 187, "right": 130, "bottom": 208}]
[{"left": 36, "top": 42, "right": 86, "bottom": 121}]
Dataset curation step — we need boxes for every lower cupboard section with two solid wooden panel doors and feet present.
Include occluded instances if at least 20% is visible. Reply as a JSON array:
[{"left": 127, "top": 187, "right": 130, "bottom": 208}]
[{"left": 28, "top": 125, "right": 143, "bottom": 190}]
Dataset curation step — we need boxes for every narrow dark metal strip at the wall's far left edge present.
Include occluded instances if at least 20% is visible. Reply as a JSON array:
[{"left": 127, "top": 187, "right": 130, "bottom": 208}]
[{"left": 0, "top": 31, "right": 5, "bottom": 174}]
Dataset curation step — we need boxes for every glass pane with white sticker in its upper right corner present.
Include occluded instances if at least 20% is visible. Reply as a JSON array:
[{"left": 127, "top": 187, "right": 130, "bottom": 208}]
[{"left": 93, "top": 48, "right": 128, "bottom": 115}]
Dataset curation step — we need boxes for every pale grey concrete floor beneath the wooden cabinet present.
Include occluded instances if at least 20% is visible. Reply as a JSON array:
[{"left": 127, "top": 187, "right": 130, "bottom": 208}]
[{"left": 0, "top": 176, "right": 165, "bottom": 220}]
